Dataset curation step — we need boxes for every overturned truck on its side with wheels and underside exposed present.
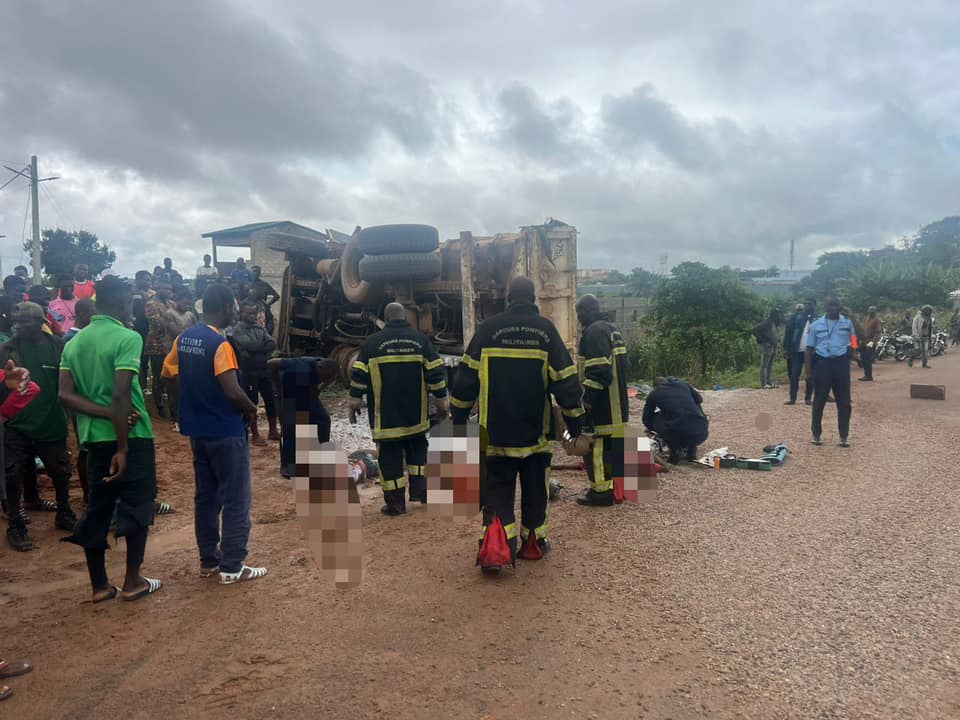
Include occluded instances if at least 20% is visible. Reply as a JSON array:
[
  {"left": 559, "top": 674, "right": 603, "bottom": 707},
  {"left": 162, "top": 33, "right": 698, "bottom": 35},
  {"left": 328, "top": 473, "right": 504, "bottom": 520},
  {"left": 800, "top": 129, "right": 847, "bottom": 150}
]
[{"left": 267, "top": 220, "right": 577, "bottom": 384}]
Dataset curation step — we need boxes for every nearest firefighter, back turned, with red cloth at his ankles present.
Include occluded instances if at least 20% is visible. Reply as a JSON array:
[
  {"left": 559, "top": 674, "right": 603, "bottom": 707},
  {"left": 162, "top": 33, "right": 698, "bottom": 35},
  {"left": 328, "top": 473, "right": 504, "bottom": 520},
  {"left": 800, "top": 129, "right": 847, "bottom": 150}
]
[{"left": 450, "top": 277, "right": 585, "bottom": 573}]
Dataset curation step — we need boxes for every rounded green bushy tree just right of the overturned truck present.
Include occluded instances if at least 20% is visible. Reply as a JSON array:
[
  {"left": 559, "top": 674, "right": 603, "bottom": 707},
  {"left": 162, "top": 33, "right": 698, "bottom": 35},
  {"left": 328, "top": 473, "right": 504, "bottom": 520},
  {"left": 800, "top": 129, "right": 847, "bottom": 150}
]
[{"left": 649, "top": 262, "right": 765, "bottom": 378}]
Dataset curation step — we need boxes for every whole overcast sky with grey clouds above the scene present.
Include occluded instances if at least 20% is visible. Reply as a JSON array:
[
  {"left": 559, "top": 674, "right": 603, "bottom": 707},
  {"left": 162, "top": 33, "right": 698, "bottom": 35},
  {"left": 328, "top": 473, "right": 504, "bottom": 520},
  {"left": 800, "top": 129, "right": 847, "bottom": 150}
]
[{"left": 0, "top": 0, "right": 960, "bottom": 272}]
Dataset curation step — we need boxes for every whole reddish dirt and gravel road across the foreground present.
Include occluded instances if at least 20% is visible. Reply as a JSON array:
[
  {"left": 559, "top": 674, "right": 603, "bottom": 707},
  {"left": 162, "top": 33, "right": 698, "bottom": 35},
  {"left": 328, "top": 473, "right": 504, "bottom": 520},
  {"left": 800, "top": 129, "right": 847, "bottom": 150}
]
[{"left": 0, "top": 353, "right": 960, "bottom": 720}]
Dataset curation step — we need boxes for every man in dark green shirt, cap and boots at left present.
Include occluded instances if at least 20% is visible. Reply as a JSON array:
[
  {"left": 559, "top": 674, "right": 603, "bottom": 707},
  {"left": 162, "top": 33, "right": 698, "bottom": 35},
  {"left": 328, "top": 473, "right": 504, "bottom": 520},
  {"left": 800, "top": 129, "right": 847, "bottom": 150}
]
[{"left": 0, "top": 302, "right": 77, "bottom": 550}]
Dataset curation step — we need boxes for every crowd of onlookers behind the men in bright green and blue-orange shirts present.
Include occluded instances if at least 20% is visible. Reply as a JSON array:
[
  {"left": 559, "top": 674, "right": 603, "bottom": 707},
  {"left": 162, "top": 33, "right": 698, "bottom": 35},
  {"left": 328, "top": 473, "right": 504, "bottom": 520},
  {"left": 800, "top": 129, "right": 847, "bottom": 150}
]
[{"left": 0, "top": 255, "right": 280, "bottom": 550}]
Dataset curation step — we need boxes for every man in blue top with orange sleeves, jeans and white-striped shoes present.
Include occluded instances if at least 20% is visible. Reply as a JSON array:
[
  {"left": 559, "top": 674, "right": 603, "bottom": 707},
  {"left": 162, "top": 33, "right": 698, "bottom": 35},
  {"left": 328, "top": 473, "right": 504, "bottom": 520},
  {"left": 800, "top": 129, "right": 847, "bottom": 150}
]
[{"left": 163, "top": 284, "right": 267, "bottom": 585}]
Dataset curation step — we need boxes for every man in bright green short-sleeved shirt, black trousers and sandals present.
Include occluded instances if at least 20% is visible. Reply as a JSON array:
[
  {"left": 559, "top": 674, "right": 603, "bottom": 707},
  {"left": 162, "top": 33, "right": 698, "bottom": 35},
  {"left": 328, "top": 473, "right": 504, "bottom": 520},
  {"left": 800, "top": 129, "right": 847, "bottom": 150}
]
[{"left": 60, "top": 276, "right": 162, "bottom": 602}]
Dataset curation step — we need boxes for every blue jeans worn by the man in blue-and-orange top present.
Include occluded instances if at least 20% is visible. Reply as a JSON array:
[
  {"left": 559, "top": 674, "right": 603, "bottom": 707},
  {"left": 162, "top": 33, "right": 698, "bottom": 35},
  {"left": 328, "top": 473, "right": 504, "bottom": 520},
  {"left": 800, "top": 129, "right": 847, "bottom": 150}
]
[{"left": 190, "top": 436, "right": 250, "bottom": 573}]
